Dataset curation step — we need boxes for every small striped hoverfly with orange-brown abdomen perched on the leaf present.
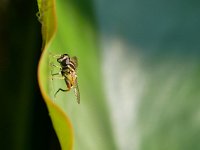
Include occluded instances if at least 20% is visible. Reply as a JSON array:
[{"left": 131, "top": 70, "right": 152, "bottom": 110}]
[{"left": 52, "top": 54, "right": 80, "bottom": 104}]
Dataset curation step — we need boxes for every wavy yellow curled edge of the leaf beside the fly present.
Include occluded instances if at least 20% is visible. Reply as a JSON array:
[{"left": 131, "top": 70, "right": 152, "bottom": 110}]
[{"left": 38, "top": 0, "right": 73, "bottom": 150}]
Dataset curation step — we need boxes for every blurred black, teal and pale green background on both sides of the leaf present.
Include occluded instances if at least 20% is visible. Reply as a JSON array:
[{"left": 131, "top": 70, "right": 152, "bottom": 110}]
[{"left": 0, "top": 0, "right": 200, "bottom": 150}]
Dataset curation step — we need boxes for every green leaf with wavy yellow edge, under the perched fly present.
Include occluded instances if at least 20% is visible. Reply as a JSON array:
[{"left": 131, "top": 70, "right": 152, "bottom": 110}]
[{"left": 38, "top": 0, "right": 116, "bottom": 150}]
